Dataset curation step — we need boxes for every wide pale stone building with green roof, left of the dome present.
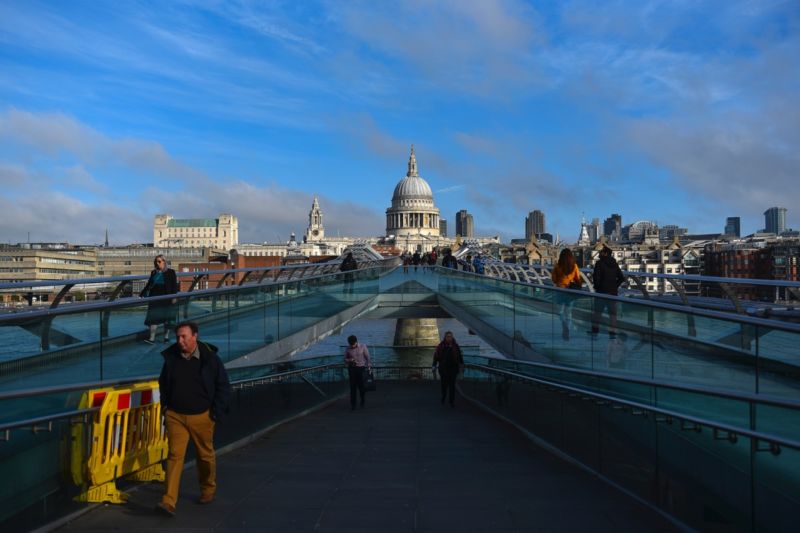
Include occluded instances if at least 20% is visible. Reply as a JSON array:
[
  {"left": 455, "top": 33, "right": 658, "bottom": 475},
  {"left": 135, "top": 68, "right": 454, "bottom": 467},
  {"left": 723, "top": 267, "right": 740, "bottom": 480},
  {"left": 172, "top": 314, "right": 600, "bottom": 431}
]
[{"left": 153, "top": 214, "right": 239, "bottom": 250}]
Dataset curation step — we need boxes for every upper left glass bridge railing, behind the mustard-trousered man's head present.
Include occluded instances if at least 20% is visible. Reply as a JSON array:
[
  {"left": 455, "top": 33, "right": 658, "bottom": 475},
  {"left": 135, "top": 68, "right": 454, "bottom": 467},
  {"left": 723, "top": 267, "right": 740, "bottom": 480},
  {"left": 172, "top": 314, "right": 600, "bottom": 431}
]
[{"left": 0, "top": 260, "right": 395, "bottom": 390}]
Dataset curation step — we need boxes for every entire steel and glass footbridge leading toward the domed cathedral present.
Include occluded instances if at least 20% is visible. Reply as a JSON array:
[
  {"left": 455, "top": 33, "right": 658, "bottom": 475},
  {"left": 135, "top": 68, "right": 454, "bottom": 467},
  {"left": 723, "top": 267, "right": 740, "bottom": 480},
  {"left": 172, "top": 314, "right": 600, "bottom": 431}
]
[{"left": 0, "top": 258, "right": 800, "bottom": 531}]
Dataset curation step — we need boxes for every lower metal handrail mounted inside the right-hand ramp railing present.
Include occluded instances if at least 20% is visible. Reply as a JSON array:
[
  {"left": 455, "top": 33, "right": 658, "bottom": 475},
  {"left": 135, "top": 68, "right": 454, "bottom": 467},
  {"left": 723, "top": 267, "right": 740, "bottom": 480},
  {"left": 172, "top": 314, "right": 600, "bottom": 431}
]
[{"left": 466, "top": 363, "right": 800, "bottom": 450}]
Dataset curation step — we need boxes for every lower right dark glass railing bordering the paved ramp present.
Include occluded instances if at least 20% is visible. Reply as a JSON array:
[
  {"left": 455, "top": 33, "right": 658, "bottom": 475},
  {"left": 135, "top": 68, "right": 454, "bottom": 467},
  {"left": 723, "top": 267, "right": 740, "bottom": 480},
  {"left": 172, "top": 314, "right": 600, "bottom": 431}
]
[{"left": 461, "top": 361, "right": 800, "bottom": 531}]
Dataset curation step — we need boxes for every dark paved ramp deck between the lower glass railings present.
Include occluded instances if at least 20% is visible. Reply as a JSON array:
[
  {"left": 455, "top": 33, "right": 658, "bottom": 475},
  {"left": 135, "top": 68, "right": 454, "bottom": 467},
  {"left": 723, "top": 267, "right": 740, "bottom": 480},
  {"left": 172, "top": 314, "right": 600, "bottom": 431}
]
[{"left": 63, "top": 382, "right": 675, "bottom": 532}]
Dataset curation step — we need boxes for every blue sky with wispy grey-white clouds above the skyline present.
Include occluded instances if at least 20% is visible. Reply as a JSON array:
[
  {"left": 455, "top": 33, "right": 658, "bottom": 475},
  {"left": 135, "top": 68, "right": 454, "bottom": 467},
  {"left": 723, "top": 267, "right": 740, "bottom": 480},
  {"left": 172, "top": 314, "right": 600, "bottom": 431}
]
[{"left": 0, "top": 0, "right": 800, "bottom": 245}]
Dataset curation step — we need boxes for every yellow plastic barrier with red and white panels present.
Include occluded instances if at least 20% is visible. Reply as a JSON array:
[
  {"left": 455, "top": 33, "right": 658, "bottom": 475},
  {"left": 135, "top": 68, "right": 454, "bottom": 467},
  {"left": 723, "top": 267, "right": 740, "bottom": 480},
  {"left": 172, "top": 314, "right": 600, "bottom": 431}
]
[{"left": 71, "top": 381, "right": 168, "bottom": 503}]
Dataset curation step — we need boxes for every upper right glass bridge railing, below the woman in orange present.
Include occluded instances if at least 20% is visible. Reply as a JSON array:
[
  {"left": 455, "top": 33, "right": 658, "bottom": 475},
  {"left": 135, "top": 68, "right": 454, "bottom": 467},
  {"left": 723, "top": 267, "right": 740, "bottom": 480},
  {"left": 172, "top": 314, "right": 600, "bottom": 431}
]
[{"left": 436, "top": 269, "right": 800, "bottom": 404}]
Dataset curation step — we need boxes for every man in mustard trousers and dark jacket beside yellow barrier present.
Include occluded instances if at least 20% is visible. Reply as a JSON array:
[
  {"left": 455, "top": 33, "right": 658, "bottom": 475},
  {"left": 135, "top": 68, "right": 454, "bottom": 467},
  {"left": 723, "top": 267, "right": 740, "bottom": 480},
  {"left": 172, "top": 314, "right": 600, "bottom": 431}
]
[{"left": 158, "top": 322, "right": 231, "bottom": 516}]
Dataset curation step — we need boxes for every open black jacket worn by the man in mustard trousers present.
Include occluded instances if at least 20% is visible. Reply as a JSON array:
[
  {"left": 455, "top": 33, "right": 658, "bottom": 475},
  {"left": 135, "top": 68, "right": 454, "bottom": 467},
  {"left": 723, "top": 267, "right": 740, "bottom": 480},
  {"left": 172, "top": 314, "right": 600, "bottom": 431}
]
[{"left": 158, "top": 341, "right": 231, "bottom": 420}]
